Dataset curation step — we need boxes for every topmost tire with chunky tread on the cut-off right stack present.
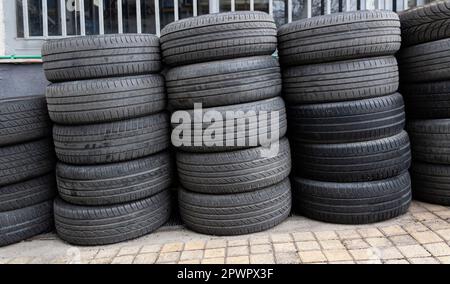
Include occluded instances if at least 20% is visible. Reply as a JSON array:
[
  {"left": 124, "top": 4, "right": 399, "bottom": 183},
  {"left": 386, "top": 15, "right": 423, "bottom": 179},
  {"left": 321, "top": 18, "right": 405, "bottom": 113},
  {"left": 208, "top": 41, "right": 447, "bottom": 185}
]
[{"left": 399, "top": 1, "right": 450, "bottom": 46}]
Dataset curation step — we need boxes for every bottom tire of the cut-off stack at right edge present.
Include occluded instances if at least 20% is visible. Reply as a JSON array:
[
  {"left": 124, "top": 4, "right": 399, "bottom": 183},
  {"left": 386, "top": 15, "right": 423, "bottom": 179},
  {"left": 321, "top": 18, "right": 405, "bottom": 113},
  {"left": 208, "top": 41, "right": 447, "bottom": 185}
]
[{"left": 411, "top": 161, "right": 450, "bottom": 206}]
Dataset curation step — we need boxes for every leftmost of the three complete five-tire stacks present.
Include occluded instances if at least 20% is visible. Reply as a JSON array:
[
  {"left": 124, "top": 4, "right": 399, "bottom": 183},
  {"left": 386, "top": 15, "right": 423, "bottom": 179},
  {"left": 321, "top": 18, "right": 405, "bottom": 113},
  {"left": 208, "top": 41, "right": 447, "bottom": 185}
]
[{"left": 42, "top": 34, "right": 173, "bottom": 245}]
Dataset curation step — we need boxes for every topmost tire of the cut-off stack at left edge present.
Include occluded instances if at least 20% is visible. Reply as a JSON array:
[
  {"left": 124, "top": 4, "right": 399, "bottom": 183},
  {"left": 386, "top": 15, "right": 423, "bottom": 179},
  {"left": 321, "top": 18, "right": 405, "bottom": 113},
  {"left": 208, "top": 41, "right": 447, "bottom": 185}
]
[{"left": 0, "top": 96, "right": 51, "bottom": 147}]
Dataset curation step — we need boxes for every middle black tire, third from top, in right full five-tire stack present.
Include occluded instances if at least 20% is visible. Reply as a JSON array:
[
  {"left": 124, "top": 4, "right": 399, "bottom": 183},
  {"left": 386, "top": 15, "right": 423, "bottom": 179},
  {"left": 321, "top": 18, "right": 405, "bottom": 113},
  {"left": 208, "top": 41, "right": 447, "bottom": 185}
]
[{"left": 287, "top": 93, "right": 405, "bottom": 143}]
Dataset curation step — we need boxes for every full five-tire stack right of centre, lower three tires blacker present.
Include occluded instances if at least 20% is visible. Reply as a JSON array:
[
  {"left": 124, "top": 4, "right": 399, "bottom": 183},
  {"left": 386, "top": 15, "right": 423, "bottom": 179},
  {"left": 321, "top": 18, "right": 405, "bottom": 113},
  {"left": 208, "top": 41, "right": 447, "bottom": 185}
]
[{"left": 278, "top": 11, "right": 411, "bottom": 224}]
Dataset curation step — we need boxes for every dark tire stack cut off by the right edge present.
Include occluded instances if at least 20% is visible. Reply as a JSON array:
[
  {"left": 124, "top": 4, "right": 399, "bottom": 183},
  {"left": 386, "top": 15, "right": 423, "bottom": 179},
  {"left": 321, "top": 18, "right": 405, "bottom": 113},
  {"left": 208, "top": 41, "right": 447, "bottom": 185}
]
[{"left": 398, "top": 1, "right": 450, "bottom": 206}]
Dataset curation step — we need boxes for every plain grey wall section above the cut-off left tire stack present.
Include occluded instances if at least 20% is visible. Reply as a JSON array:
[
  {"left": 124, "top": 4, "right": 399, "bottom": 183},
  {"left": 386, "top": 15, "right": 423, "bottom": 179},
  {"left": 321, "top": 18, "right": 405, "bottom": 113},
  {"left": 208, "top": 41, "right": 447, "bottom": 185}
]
[{"left": 0, "top": 64, "right": 50, "bottom": 99}]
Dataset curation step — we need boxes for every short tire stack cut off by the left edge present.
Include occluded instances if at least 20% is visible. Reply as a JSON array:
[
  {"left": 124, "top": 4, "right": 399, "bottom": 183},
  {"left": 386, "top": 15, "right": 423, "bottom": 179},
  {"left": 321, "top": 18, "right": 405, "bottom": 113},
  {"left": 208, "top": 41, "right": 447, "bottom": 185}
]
[{"left": 0, "top": 95, "right": 56, "bottom": 247}]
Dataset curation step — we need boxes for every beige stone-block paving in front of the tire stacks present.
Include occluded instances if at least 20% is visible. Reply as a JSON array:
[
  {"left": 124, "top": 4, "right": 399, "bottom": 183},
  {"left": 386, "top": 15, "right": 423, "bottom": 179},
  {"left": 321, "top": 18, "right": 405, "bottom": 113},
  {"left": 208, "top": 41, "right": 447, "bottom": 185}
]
[{"left": 0, "top": 201, "right": 450, "bottom": 264}]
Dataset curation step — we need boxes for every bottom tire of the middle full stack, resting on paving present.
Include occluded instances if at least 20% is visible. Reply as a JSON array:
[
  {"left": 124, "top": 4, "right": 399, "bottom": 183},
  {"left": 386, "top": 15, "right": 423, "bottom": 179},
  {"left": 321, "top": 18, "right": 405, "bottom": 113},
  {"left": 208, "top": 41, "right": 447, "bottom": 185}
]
[{"left": 178, "top": 179, "right": 292, "bottom": 236}]
